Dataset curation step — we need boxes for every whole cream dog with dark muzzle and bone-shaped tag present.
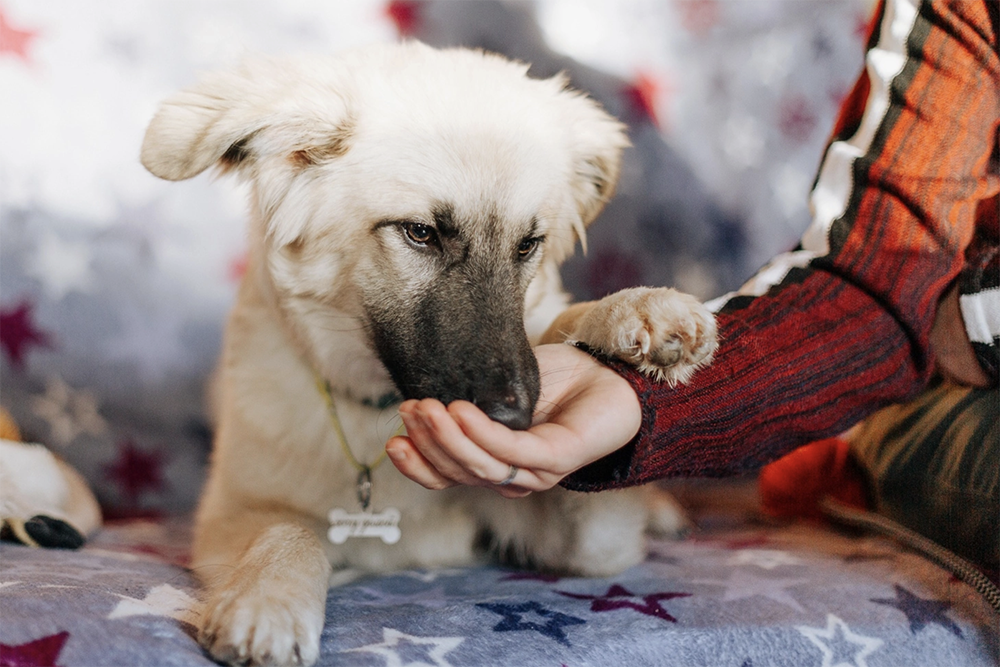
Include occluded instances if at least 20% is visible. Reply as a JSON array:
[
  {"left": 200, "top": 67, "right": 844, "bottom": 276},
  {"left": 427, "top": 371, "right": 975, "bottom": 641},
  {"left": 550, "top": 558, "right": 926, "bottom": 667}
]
[{"left": 142, "top": 43, "right": 715, "bottom": 665}]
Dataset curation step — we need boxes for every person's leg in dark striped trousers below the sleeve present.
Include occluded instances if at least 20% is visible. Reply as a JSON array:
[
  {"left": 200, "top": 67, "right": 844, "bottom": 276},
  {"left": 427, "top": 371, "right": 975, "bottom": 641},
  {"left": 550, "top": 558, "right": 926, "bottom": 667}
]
[{"left": 850, "top": 383, "right": 1000, "bottom": 567}]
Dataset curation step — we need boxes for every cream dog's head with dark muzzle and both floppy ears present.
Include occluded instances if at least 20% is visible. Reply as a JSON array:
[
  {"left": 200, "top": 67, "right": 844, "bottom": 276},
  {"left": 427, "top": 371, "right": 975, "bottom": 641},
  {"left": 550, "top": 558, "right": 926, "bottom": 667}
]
[{"left": 142, "top": 43, "right": 627, "bottom": 428}]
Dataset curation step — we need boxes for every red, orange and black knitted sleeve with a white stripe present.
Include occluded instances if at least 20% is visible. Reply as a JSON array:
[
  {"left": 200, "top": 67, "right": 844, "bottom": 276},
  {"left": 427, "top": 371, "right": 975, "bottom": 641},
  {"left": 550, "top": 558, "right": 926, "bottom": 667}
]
[{"left": 563, "top": 0, "right": 1000, "bottom": 490}]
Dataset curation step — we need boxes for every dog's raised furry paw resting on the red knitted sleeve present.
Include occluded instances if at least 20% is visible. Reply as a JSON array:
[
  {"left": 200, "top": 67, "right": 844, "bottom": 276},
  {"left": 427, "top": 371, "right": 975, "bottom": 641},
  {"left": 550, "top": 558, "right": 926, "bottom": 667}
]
[{"left": 574, "top": 287, "right": 717, "bottom": 386}]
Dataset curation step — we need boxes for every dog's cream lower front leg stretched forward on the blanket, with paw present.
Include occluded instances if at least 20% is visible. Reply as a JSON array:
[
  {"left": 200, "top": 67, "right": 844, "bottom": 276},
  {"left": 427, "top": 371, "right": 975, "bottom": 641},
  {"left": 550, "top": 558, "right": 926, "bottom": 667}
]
[{"left": 195, "top": 516, "right": 330, "bottom": 667}]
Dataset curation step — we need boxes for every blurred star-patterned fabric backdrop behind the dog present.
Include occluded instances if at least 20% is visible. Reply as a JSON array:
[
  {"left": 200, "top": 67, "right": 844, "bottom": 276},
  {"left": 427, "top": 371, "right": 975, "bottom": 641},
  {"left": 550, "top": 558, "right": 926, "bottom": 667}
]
[{"left": 0, "top": 0, "right": 871, "bottom": 517}]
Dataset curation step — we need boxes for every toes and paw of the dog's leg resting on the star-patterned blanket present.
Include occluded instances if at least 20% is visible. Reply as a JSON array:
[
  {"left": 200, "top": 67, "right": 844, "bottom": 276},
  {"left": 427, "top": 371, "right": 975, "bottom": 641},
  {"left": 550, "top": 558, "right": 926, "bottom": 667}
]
[{"left": 198, "top": 589, "right": 324, "bottom": 667}]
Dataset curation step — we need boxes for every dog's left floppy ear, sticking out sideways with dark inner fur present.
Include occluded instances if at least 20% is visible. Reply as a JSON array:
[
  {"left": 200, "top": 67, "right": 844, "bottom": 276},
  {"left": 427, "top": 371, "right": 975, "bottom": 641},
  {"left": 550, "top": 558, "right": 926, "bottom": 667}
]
[{"left": 141, "top": 59, "right": 349, "bottom": 181}]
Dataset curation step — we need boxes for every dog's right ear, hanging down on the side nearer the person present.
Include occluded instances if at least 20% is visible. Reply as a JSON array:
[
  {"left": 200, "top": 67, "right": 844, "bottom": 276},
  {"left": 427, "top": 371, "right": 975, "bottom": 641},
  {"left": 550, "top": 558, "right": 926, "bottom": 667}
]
[{"left": 563, "top": 80, "right": 630, "bottom": 247}]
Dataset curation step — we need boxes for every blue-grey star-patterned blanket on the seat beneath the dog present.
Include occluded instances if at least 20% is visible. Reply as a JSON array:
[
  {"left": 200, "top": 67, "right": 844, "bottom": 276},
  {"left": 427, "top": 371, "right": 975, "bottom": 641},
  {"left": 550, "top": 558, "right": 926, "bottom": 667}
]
[{"left": 0, "top": 500, "right": 1000, "bottom": 667}]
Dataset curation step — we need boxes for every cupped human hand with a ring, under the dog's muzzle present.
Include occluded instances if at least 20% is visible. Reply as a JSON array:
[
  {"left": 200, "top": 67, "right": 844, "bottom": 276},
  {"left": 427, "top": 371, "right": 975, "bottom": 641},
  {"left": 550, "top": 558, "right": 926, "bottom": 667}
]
[{"left": 385, "top": 344, "right": 642, "bottom": 498}]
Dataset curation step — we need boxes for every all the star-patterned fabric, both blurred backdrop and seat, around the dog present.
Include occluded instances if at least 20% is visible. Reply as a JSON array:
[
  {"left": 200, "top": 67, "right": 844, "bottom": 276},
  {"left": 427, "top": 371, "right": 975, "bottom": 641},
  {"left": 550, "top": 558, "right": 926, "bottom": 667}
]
[{"left": 0, "top": 0, "right": 1000, "bottom": 667}]
